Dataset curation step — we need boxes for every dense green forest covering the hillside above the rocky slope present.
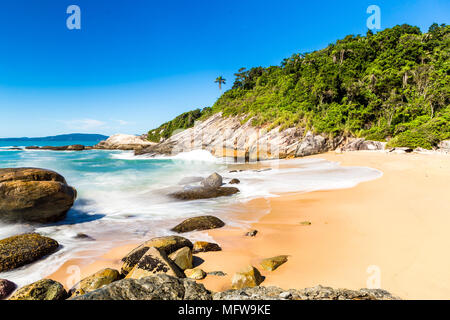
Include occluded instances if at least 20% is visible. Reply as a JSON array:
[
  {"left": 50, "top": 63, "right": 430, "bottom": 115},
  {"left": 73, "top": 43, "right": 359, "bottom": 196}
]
[{"left": 149, "top": 24, "right": 450, "bottom": 149}]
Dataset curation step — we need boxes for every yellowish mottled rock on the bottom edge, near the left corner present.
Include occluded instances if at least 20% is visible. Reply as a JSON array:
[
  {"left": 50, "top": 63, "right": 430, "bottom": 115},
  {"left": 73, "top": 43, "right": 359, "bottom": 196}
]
[{"left": 9, "top": 279, "right": 67, "bottom": 300}]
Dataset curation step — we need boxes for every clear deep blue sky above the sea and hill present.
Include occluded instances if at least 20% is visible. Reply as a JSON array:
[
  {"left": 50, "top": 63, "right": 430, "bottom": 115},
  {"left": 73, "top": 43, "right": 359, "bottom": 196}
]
[{"left": 0, "top": 0, "right": 450, "bottom": 137}]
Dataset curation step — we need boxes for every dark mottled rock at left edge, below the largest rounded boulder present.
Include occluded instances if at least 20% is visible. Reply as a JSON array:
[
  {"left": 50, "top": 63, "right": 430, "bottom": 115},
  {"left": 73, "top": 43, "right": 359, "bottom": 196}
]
[{"left": 0, "top": 233, "right": 59, "bottom": 272}]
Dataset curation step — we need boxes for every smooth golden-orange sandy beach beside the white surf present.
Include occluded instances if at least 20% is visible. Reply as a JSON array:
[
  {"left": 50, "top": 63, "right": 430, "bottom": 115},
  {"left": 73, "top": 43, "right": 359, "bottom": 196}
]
[{"left": 48, "top": 152, "right": 450, "bottom": 299}]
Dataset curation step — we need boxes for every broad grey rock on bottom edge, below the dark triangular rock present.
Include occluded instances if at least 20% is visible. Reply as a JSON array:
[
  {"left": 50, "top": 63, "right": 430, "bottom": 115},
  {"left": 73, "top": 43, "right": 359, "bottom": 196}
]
[{"left": 71, "top": 274, "right": 211, "bottom": 300}]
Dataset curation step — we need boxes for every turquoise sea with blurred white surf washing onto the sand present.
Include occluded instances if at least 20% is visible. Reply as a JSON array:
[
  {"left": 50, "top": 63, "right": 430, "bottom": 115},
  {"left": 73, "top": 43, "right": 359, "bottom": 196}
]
[{"left": 0, "top": 141, "right": 382, "bottom": 285}]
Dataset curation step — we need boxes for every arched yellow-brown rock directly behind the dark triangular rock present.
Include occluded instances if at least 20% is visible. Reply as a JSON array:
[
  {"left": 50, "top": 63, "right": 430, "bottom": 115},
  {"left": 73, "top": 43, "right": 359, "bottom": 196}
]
[{"left": 121, "top": 236, "right": 193, "bottom": 275}]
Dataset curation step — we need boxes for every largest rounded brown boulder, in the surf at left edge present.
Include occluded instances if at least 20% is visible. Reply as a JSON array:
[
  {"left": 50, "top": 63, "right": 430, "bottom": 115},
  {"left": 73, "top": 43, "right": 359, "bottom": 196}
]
[{"left": 0, "top": 168, "right": 77, "bottom": 223}]
